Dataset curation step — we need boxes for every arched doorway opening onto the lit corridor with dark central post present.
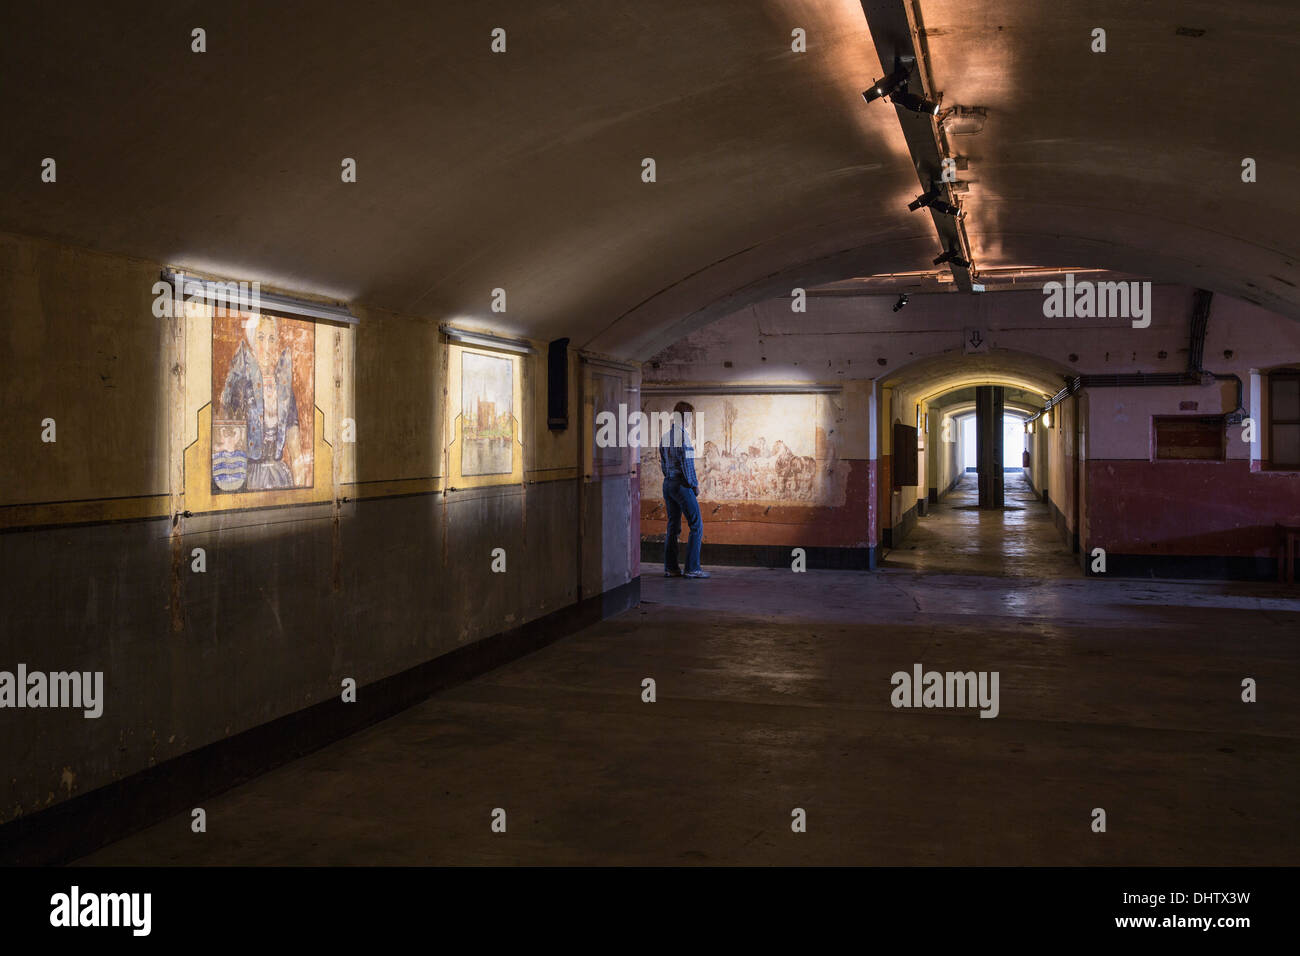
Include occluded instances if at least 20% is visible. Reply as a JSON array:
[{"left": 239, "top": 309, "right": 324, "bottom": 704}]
[{"left": 879, "top": 355, "right": 1082, "bottom": 578}]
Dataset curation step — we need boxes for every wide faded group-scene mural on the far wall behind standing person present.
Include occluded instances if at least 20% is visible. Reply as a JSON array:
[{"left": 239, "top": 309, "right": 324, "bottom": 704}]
[{"left": 641, "top": 394, "right": 845, "bottom": 506}]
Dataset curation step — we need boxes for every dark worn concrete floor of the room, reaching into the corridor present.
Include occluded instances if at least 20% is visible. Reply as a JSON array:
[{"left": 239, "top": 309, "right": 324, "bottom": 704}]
[{"left": 82, "top": 481, "right": 1300, "bottom": 865}]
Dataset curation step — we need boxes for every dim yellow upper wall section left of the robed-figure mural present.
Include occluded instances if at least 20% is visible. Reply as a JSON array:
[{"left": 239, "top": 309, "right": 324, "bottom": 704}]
[{"left": 0, "top": 235, "right": 168, "bottom": 527}]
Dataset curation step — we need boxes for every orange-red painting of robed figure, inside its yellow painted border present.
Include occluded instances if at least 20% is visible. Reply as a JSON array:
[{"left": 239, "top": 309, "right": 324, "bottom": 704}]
[{"left": 212, "top": 311, "right": 316, "bottom": 496}]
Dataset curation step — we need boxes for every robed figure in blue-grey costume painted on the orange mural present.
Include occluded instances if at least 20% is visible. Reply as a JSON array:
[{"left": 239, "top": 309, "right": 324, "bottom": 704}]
[{"left": 212, "top": 315, "right": 312, "bottom": 492}]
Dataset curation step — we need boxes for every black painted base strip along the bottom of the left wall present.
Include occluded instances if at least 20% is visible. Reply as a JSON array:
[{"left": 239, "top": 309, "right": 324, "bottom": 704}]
[{"left": 0, "top": 578, "right": 641, "bottom": 866}]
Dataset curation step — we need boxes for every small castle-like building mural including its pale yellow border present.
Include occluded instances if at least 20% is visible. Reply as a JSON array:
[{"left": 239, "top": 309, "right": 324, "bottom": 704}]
[{"left": 447, "top": 345, "right": 524, "bottom": 488}]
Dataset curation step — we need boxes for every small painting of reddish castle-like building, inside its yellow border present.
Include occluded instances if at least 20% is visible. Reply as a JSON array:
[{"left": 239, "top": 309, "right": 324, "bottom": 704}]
[{"left": 460, "top": 351, "right": 515, "bottom": 477}]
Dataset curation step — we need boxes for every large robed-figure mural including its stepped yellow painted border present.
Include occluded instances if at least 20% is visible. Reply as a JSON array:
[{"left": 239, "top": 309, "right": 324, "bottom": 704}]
[{"left": 183, "top": 304, "right": 334, "bottom": 514}]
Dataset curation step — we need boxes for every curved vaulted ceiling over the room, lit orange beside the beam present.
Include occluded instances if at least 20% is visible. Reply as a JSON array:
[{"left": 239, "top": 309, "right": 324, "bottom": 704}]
[{"left": 0, "top": 0, "right": 1300, "bottom": 358}]
